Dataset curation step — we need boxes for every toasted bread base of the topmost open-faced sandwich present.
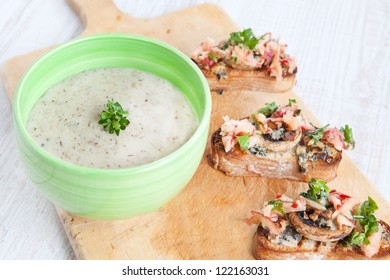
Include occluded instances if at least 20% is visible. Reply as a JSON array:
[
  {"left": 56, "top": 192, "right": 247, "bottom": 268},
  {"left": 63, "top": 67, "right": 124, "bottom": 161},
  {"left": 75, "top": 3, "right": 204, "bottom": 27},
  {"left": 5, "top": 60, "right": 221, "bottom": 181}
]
[{"left": 201, "top": 67, "right": 297, "bottom": 93}]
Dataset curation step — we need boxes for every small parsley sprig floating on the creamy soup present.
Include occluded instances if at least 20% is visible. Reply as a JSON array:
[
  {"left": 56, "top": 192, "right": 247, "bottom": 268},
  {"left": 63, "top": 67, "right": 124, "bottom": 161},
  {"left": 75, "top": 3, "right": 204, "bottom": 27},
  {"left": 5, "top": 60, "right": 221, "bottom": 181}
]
[{"left": 98, "top": 99, "right": 130, "bottom": 135}]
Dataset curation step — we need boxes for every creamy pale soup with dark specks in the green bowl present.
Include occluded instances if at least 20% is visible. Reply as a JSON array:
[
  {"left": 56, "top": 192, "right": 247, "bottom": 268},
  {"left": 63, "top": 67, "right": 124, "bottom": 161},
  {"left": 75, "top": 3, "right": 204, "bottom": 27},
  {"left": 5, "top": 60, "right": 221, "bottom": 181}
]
[{"left": 27, "top": 68, "right": 198, "bottom": 168}]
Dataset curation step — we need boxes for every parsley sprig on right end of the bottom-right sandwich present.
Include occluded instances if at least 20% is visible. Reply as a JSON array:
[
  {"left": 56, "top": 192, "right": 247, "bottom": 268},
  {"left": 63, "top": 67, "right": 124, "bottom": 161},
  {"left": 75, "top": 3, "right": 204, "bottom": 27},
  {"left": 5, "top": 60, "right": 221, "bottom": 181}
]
[{"left": 347, "top": 197, "right": 379, "bottom": 247}]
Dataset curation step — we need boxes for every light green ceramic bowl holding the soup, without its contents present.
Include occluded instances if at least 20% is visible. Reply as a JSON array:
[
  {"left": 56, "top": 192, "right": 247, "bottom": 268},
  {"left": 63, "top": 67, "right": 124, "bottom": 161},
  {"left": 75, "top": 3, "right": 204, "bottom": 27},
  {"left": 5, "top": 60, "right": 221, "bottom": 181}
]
[{"left": 13, "top": 34, "right": 211, "bottom": 219}]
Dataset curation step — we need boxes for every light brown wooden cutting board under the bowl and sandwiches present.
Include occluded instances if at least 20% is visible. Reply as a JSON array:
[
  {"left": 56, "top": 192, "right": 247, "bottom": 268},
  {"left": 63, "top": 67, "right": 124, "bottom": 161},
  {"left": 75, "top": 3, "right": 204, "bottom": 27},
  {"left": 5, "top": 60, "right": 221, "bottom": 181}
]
[{"left": 2, "top": 0, "right": 390, "bottom": 259}]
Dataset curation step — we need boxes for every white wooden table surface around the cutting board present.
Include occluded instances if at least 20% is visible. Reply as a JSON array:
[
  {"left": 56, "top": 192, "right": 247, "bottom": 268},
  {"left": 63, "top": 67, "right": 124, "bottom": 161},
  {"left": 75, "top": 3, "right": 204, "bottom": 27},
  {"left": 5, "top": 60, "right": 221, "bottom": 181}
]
[{"left": 0, "top": 0, "right": 390, "bottom": 259}]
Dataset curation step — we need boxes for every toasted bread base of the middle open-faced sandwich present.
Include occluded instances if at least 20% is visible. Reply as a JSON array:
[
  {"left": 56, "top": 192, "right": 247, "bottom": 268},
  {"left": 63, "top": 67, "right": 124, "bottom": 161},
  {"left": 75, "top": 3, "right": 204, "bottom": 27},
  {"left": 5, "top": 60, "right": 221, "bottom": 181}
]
[{"left": 209, "top": 129, "right": 342, "bottom": 182}]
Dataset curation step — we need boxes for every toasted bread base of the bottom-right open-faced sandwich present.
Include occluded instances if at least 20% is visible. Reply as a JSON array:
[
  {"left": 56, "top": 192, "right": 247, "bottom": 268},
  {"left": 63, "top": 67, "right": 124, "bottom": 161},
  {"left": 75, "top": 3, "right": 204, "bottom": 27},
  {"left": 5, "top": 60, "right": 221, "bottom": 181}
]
[{"left": 253, "top": 221, "right": 390, "bottom": 260}]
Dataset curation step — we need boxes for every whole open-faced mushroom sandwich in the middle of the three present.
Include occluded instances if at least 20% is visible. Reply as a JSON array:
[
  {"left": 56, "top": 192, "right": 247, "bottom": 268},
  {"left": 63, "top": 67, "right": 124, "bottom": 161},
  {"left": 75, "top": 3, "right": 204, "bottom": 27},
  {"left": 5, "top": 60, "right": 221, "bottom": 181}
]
[{"left": 209, "top": 99, "right": 355, "bottom": 182}]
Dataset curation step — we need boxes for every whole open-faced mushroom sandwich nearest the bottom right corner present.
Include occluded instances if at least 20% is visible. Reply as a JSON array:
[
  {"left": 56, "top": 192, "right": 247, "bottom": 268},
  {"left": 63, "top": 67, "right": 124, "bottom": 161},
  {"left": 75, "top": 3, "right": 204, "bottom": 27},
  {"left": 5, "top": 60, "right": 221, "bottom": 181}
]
[{"left": 246, "top": 179, "right": 390, "bottom": 259}]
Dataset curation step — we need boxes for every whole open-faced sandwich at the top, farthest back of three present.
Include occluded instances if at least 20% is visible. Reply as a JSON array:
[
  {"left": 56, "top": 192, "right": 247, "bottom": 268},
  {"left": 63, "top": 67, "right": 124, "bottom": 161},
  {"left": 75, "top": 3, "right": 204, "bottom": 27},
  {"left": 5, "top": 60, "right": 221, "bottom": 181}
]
[{"left": 191, "top": 28, "right": 297, "bottom": 92}]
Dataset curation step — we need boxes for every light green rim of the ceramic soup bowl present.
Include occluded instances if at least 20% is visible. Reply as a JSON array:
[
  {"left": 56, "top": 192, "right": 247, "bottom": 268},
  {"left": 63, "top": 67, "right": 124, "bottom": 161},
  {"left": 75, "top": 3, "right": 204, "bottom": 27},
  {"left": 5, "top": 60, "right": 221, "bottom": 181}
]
[{"left": 13, "top": 33, "right": 211, "bottom": 175}]
